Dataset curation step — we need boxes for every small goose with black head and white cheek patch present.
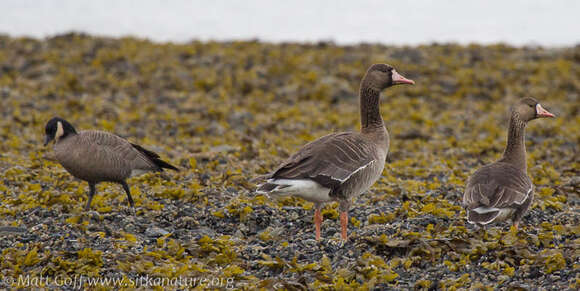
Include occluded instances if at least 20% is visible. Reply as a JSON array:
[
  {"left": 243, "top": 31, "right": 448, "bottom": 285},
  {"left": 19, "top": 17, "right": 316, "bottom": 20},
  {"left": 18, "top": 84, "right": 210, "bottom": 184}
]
[{"left": 44, "top": 117, "right": 178, "bottom": 210}]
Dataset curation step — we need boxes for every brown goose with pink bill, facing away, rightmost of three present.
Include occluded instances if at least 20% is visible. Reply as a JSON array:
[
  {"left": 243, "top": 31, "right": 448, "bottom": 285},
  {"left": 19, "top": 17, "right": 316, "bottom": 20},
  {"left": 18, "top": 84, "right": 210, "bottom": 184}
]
[{"left": 463, "top": 97, "right": 554, "bottom": 228}]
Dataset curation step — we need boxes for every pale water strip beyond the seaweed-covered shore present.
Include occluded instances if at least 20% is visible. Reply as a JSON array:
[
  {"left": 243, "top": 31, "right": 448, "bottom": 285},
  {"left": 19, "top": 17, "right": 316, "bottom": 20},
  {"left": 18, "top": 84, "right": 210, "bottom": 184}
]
[{"left": 0, "top": 0, "right": 580, "bottom": 46}]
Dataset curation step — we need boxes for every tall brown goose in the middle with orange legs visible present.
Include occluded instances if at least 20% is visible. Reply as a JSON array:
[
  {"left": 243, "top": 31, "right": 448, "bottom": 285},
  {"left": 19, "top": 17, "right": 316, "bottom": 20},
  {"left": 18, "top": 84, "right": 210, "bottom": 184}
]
[{"left": 256, "top": 64, "right": 415, "bottom": 240}]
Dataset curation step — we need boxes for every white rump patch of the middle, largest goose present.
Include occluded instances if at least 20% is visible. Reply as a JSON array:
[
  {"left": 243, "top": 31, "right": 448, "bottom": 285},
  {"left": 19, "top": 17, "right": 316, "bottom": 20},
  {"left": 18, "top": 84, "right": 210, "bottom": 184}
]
[{"left": 256, "top": 179, "right": 332, "bottom": 202}]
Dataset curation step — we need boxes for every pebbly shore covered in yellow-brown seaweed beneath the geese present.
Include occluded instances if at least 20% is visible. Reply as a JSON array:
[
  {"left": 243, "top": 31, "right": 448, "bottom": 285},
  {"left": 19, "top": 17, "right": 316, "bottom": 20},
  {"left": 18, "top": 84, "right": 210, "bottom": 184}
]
[{"left": 0, "top": 34, "right": 580, "bottom": 290}]
